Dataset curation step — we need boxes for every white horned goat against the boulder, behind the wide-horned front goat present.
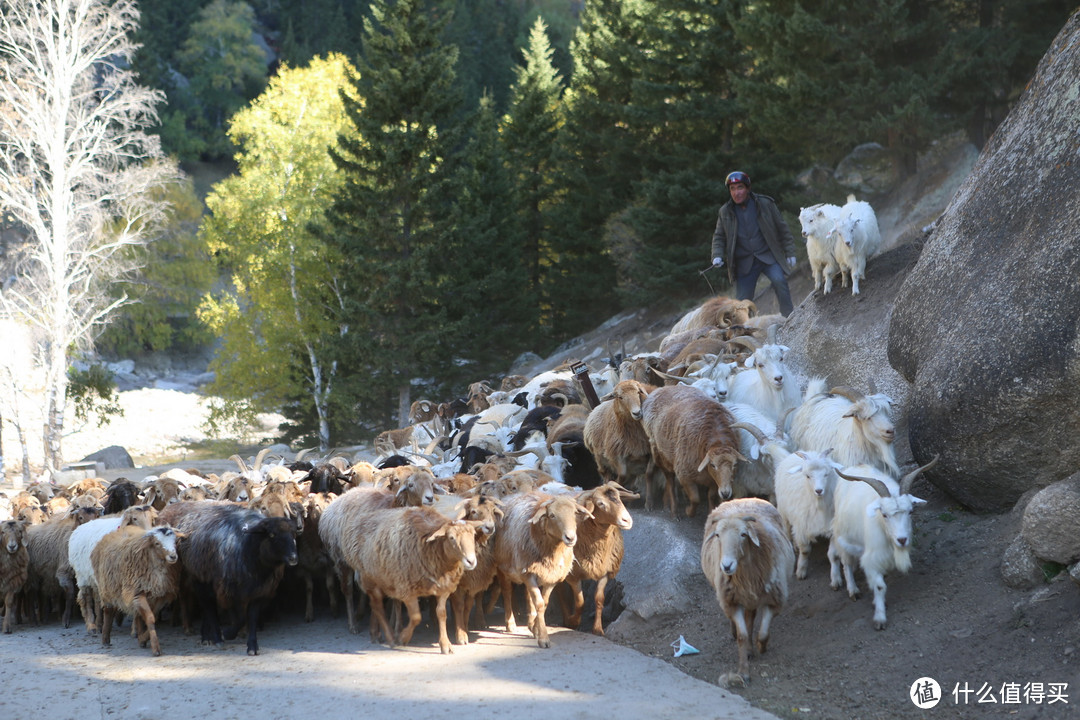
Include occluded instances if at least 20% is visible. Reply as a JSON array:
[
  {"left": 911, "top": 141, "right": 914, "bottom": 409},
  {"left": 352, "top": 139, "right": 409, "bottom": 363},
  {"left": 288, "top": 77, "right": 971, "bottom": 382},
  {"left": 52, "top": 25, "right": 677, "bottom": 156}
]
[{"left": 791, "top": 378, "right": 900, "bottom": 475}]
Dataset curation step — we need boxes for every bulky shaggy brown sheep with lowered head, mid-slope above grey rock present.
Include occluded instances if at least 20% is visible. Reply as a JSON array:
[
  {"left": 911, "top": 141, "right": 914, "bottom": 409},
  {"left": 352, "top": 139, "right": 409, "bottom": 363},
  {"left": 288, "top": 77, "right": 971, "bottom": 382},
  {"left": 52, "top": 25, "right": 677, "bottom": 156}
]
[{"left": 642, "top": 385, "right": 745, "bottom": 517}]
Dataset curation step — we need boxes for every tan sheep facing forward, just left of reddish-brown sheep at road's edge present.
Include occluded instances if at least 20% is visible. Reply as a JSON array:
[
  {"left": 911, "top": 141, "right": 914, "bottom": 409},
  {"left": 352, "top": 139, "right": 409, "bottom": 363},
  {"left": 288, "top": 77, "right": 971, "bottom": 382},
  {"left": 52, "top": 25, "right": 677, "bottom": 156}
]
[{"left": 495, "top": 492, "right": 591, "bottom": 648}]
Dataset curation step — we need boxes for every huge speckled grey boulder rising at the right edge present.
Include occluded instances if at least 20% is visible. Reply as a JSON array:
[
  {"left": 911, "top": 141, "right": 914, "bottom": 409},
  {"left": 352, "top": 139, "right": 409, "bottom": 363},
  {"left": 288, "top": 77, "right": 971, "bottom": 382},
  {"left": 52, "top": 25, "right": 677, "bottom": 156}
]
[{"left": 888, "top": 15, "right": 1080, "bottom": 511}]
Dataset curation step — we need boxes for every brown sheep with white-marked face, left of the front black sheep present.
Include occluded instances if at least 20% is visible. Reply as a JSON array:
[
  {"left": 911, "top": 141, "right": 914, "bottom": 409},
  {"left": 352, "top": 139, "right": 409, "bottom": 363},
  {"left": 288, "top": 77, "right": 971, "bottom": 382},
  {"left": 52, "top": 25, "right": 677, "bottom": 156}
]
[{"left": 90, "top": 526, "right": 180, "bottom": 657}]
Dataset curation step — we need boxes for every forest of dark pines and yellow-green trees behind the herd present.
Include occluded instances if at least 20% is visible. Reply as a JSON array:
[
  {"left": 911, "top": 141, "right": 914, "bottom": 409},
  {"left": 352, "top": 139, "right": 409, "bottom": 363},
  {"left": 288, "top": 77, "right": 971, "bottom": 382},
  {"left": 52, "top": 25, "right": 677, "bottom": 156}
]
[{"left": 3, "top": 0, "right": 1075, "bottom": 472}]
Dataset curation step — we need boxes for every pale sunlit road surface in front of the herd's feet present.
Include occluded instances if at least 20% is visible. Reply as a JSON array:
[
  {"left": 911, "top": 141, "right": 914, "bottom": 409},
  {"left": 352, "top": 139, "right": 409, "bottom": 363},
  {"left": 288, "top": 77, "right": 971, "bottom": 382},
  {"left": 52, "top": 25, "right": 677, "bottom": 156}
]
[{"left": 0, "top": 616, "right": 774, "bottom": 720}]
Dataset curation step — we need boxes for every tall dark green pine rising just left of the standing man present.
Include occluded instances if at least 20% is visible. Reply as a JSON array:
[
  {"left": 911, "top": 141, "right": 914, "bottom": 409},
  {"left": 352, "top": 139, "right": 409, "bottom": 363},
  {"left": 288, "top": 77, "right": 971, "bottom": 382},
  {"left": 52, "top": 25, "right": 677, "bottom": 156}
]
[{"left": 607, "top": 0, "right": 747, "bottom": 303}]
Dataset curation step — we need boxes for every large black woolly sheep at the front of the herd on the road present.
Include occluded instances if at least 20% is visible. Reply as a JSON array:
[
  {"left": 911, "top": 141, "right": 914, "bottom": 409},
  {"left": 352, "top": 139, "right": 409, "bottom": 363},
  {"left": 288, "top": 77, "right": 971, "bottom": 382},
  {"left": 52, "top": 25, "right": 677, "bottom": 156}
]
[{"left": 159, "top": 501, "right": 298, "bottom": 655}]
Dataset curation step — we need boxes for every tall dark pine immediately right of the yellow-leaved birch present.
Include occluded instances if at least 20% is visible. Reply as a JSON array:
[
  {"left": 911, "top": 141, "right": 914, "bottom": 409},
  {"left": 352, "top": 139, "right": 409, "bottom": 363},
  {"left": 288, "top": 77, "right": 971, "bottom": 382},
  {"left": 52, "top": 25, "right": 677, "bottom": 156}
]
[{"left": 328, "top": 0, "right": 459, "bottom": 427}]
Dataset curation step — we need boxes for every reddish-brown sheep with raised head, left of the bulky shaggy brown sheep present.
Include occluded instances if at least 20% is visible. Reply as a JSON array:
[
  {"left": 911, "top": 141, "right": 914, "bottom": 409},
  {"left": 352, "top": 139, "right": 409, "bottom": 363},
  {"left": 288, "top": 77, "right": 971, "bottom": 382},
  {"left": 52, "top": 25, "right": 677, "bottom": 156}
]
[{"left": 584, "top": 380, "right": 654, "bottom": 510}]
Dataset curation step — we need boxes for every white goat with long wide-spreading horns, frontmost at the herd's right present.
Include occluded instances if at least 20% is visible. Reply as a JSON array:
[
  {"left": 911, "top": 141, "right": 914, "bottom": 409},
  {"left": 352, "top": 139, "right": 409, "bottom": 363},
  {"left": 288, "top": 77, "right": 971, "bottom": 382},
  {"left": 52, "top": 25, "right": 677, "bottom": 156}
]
[{"left": 829, "top": 457, "right": 937, "bottom": 630}]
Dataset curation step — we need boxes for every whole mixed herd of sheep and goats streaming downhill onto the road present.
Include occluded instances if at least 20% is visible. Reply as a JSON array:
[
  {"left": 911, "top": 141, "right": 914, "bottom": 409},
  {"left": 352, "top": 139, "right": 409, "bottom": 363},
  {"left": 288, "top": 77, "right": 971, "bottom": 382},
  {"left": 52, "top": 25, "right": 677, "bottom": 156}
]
[{"left": 0, "top": 296, "right": 932, "bottom": 684}]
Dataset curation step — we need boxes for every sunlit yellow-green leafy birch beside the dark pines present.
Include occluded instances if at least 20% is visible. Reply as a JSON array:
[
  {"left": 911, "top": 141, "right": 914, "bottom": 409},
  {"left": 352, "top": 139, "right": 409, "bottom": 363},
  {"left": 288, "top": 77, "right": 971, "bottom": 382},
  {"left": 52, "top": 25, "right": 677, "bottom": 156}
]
[{"left": 200, "top": 54, "right": 353, "bottom": 449}]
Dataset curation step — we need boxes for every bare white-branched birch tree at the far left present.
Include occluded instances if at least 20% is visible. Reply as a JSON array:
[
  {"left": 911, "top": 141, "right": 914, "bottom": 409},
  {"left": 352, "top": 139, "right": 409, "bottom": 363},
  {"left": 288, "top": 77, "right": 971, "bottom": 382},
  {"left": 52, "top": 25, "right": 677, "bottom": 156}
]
[{"left": 0, "top": 0, "right": 176, "bottom": 471}]
